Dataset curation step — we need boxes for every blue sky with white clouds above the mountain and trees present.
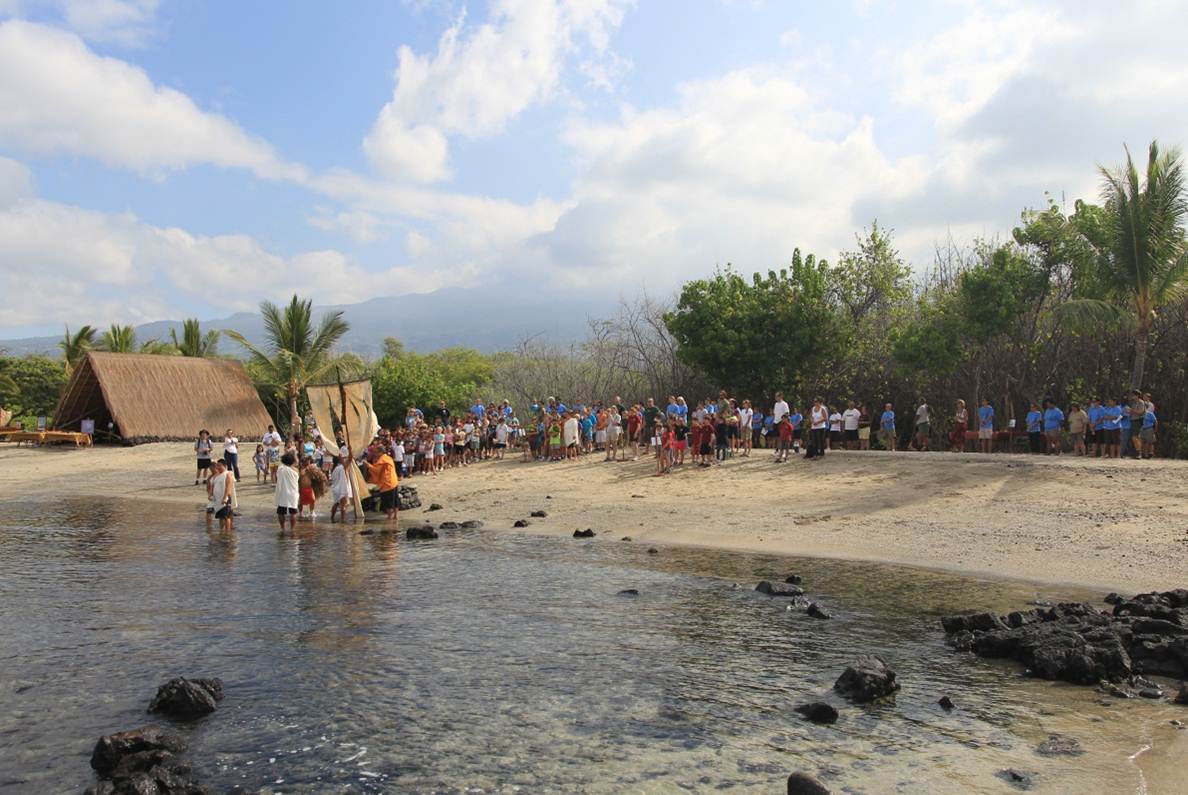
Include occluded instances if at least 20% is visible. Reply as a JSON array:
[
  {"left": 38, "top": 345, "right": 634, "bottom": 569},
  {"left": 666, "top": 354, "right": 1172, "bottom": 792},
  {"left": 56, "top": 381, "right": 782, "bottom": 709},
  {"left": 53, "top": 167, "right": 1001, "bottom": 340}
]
[{"left": 0, "top": 0, "right": 1188, "bottom": 339}]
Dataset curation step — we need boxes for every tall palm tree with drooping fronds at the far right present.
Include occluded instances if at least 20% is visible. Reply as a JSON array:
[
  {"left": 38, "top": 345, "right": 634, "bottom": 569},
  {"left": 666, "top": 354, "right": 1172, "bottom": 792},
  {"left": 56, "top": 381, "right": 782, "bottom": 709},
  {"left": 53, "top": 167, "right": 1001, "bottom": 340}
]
[{"left": 1067, "top": 141, "right": 1188, "bottom": 389}]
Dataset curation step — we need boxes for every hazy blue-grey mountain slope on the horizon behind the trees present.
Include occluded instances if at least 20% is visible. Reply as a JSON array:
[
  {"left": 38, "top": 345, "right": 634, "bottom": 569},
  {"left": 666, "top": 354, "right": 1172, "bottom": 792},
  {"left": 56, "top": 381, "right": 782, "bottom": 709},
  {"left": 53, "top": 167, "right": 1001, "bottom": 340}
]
[{"left": 0, "top": 286, "right": 618, "bottom": 355}]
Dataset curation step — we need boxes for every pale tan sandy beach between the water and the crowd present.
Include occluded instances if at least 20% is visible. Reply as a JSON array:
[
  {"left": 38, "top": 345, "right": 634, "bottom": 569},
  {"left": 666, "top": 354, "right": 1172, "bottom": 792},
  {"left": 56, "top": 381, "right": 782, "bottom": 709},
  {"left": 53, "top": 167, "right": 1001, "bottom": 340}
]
[{"left": 0, "top": 443, "right": 1188, "bottom": 593}]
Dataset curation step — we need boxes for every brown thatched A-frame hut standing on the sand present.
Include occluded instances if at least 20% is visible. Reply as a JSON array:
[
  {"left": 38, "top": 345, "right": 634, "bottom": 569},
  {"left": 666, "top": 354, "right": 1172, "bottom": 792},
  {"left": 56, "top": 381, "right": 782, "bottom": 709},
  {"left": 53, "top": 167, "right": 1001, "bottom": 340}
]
[{"left": 53, "top": 351, "right": 272, "bottom": 441}]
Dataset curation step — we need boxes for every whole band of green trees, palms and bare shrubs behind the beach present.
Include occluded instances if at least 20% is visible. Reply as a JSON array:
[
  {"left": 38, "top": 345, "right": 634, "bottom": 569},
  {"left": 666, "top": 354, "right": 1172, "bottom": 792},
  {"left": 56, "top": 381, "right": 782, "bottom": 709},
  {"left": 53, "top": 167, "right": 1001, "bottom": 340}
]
[{"left": 0, "top": 144, "right": 1188, "bottom": 455}]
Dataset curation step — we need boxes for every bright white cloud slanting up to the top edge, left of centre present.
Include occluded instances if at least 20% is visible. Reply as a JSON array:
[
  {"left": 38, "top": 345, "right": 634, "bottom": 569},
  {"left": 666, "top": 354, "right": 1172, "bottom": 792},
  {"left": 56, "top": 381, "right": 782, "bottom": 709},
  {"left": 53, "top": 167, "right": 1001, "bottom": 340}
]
[{"left": 364, "top": 0, "right": 626, "bottom": 182}]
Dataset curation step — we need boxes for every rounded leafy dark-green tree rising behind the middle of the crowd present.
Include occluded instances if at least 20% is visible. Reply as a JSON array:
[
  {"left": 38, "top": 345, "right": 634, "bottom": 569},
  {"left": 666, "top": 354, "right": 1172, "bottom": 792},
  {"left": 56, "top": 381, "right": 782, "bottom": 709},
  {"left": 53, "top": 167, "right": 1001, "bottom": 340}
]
[{"left": 664, "top": 250, "right": 843, "bottom": 399}]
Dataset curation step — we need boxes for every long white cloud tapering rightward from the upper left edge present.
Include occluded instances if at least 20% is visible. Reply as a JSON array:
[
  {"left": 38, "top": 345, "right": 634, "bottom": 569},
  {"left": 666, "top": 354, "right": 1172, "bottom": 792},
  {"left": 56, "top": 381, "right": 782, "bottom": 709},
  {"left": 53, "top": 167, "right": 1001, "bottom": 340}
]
[{"left": 0, "top": 20, "right": 305, "bottom": 179}]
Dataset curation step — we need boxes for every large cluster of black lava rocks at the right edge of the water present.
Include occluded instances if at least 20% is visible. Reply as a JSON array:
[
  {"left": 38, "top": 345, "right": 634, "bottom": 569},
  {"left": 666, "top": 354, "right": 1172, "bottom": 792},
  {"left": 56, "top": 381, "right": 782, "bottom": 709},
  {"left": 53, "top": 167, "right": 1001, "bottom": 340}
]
[{"left": 941, "top": 588, "right": 1188, "bottom": 684}]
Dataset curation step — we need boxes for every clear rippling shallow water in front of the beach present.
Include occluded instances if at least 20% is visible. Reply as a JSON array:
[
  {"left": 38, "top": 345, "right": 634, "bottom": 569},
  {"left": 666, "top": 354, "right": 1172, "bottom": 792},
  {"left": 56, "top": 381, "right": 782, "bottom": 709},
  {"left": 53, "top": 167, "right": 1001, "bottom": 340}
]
[{"left": 0, "top": 500, "right": 1188, "bottom": 793}]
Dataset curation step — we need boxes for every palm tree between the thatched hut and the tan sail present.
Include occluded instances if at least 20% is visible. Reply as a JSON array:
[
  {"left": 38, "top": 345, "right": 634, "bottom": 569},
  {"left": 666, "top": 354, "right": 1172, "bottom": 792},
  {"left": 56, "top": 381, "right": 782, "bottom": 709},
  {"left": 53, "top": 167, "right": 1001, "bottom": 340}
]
[{"left": 227, "top": 295, "right": 350, "bottom": 429}]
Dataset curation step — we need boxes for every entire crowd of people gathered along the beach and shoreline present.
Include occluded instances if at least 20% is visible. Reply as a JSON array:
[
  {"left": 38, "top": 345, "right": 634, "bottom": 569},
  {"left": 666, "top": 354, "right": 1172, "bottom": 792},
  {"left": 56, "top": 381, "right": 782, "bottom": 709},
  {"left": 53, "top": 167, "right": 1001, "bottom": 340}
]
[{"left": 194, "top": 390, "right": 1158, "bottom": 530}]
